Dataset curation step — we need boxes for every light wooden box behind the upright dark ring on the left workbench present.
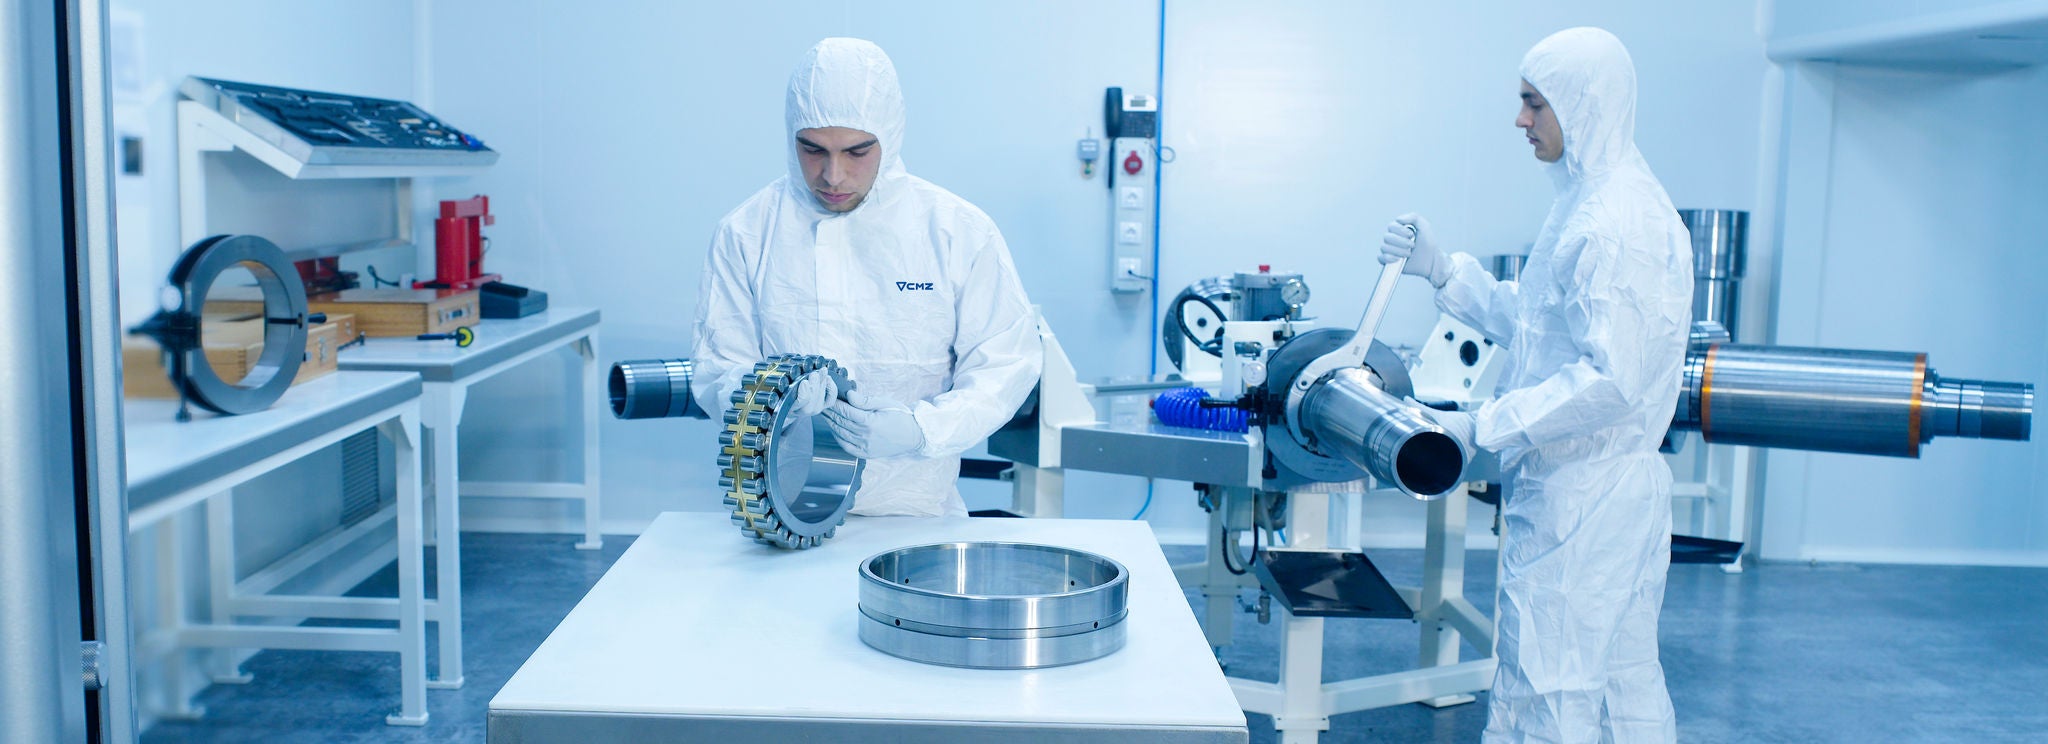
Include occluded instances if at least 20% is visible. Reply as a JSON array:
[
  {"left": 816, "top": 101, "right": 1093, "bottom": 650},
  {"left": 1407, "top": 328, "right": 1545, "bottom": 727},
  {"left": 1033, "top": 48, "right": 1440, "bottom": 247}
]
[{"left": 121, "top": 313, "right": 354, "bottom": 398}]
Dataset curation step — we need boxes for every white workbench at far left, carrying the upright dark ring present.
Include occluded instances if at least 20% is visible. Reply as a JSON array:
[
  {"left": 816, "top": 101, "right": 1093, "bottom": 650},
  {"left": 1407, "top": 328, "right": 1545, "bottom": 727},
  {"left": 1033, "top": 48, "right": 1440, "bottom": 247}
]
[{"left": 123, "top": 373, "right": 426, "bottom": 726}]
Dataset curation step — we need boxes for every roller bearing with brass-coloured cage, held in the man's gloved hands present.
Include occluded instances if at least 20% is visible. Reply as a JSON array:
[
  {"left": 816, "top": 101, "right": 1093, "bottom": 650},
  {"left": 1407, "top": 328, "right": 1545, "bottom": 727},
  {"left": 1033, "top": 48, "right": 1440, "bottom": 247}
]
[{"left": 719, "top": 355, "right": 866, "bottom": 549}]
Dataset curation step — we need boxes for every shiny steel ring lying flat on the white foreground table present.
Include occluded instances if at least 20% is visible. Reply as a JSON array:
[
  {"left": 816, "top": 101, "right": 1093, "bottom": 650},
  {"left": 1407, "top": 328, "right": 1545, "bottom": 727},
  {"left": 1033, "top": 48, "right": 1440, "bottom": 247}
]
[{"left": 860, "top": 543, "right": 1130, "bottom": 668}]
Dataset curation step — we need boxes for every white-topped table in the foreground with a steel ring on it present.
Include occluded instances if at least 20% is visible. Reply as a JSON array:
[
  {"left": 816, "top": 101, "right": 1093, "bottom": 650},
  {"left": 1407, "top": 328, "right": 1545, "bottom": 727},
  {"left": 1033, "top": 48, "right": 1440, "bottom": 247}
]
[{"left": 487, "top": 512, "right": 1247, "bottom": 744}]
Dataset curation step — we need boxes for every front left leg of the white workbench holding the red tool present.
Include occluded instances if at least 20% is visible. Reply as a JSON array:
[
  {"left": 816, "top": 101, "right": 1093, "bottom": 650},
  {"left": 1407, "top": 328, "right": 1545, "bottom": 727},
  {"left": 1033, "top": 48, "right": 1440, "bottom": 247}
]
[{"left": 420, "top": 383, "right": 469, "bottom": 691}]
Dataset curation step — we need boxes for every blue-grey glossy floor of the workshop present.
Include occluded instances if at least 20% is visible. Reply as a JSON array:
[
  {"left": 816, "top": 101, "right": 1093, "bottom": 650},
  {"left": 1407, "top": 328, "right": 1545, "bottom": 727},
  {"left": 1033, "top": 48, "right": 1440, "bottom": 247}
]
[{"left": 143, "top": 533, "right": 2048, "bottom": 742}]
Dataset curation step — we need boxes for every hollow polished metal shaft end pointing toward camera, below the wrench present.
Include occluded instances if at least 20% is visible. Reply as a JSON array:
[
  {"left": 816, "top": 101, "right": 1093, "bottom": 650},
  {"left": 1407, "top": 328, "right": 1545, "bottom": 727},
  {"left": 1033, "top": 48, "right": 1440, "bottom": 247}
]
[{"left": 1300, "top": 367, "right": 1464, "bottom": 500}]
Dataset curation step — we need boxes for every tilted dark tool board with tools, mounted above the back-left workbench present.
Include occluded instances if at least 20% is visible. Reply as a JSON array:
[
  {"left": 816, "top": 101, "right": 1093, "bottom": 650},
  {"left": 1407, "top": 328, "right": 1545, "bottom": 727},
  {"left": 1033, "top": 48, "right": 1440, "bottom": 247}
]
[{"left": 178, "top": 78, "right": 498, "bottom": 166}]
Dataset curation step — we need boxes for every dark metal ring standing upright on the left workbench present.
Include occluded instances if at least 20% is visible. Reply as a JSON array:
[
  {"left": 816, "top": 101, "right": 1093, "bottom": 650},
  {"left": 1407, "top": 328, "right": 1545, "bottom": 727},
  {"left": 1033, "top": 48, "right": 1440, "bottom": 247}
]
[{"left": 133, "top": 236, "right": 307, "bottom": 420}]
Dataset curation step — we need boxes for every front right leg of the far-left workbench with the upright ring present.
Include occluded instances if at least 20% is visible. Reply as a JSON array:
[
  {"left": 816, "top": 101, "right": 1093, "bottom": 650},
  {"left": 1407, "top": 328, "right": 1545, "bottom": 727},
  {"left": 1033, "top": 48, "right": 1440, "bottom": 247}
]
[{"left": 377, "top": 414, "right": 432, "bottom": 726}]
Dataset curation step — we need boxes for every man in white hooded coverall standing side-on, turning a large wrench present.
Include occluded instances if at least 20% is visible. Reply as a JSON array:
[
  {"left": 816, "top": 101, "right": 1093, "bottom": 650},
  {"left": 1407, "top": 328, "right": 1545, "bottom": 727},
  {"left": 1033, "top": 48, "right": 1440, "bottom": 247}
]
[{"left": 1380, "top": 29, "right": 1692, "bottom": 742}]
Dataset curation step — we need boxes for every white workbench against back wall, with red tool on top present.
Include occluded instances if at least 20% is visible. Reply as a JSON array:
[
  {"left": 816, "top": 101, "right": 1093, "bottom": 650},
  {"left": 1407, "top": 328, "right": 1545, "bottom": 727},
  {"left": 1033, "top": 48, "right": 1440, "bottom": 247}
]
[{"left": 338, "top": 307, "right": 604, "bottom": 689}]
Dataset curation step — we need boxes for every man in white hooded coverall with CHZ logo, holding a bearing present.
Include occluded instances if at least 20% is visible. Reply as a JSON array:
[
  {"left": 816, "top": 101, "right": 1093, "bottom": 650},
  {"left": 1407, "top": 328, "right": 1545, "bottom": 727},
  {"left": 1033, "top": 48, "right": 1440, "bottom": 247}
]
[{"left": 692, "top": 39, "right": 1042, "bottom": 516}]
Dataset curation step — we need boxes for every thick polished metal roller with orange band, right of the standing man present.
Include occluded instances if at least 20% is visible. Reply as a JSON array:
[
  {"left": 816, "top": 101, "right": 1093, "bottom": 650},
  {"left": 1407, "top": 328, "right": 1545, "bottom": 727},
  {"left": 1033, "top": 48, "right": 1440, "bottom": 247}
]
[{"left": 1671, "top": 344, "right": 2034, "bottom": 457}]
